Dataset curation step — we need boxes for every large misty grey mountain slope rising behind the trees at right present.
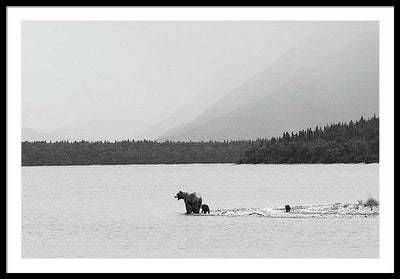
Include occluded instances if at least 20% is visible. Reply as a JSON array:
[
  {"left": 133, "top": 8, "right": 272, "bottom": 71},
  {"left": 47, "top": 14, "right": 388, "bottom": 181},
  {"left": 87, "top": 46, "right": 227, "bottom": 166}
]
[{"left": 158, "top": 22, "right": 379, "bottom": 141}]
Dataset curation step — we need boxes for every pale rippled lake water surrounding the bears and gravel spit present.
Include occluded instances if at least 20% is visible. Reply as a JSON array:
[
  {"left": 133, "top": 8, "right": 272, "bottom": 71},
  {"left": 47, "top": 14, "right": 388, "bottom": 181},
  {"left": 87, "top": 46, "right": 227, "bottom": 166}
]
[{"left": 22, "top": 164, "right": 379, "bottom": 258}]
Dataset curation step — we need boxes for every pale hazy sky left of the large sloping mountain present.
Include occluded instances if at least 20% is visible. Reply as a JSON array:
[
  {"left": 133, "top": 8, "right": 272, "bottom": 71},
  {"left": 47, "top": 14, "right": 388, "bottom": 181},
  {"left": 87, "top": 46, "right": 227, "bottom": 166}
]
[{"left": 22, "top": 21, "right": 319, "bottom": 140}]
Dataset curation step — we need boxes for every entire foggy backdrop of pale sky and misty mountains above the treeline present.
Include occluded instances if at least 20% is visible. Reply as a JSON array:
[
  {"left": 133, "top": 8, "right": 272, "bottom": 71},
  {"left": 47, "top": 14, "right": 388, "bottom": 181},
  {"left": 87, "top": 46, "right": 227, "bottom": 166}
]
[{"left": 21, "top": 21, "right": 379, "bottom": 141}]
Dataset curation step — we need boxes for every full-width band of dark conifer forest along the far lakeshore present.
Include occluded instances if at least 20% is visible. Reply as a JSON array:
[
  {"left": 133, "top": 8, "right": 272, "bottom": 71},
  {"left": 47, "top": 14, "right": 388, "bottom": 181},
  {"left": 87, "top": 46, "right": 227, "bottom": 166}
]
[{"left": 22, "top": 116, "right": 379, "bottom": 166}]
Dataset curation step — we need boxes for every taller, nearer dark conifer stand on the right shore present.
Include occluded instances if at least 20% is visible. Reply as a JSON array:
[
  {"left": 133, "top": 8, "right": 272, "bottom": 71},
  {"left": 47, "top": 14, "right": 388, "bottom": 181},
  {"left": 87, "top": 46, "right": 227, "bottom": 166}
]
[{"left": 237, "top": 115, "right": 379, "bottom": 164}]
